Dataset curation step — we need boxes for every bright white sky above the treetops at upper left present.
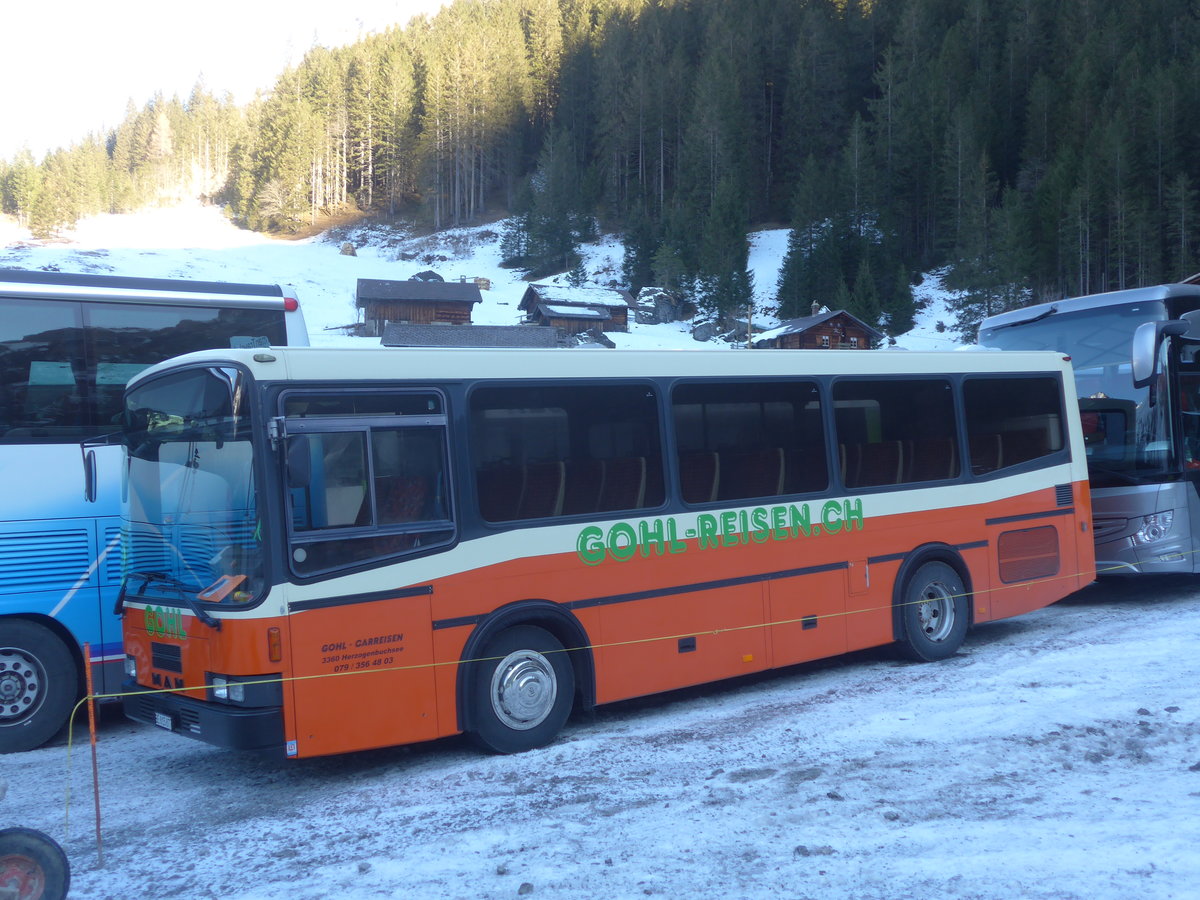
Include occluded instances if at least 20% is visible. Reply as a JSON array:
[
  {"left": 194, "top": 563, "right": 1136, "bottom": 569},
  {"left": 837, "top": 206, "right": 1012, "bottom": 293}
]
[{"left": 0, "top": 0, "right": 445, "bottom": 160}]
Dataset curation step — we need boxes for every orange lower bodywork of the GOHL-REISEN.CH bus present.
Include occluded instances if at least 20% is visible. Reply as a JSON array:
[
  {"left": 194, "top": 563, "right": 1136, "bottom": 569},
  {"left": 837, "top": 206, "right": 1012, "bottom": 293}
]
[{"left": 125, "top": 482, "right": 1094, "bottom": 756}]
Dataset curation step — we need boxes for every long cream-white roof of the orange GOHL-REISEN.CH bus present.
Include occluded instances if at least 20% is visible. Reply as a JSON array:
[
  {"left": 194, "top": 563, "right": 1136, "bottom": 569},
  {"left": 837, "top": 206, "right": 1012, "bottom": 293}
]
[{"left": 131, "top": 347, "right": 1070, "bottom": 384}]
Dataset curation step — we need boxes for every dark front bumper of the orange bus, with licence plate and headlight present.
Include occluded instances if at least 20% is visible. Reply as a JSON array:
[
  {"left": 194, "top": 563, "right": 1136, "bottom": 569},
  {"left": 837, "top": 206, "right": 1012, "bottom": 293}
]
[{"left": 121, "top": 682, "right": 283, "bottom": 756}]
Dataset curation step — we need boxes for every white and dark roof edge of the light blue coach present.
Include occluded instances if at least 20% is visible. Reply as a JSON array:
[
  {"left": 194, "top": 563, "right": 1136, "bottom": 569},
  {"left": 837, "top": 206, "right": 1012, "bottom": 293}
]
[{"left": 0, "top": 269, "right": 295, "bottom": 308}]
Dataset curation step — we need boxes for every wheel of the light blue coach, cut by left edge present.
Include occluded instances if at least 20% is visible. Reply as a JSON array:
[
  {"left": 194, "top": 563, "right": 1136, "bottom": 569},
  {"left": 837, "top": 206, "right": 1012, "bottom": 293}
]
[{"left": 0, "top": 619, "right": 79, "bottom": 754}]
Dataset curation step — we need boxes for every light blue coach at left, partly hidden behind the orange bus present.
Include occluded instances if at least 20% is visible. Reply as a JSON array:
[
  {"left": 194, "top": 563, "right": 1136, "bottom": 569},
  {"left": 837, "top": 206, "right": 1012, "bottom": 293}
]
[{"left": 0, "top": 269, "right": 308, "bottom": 752}]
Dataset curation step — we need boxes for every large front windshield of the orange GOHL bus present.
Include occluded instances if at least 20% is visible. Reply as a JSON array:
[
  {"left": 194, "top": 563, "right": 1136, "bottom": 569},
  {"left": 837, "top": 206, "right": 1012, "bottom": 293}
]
[{"left": 124, "top": 367, "right": 263, "bottom": 602}]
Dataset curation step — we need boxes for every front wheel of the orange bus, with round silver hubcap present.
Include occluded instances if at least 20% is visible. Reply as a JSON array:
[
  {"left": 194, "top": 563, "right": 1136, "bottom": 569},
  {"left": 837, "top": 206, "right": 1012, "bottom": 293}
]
[{"left": 467, "top": 625, "right": 575, "bottom": 754}]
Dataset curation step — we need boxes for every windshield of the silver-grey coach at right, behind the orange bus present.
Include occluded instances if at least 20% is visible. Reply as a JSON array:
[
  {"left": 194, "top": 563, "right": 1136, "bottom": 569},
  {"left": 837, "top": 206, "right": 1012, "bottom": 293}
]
[{"left": 979, "top": 301, "right": 1177, "bottom": 487}]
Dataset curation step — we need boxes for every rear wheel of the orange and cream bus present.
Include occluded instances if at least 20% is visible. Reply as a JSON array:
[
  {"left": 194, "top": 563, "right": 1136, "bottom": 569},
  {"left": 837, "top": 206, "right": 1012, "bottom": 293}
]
[{"left": 900, "top": 562, "right": 971, "bottom": 662}]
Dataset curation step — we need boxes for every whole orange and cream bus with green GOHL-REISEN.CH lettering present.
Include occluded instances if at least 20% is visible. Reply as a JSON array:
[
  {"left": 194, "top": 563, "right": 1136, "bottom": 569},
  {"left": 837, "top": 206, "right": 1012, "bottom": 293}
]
[{"left": 114, "top": 348, "right": 1093, "bottom": 757}]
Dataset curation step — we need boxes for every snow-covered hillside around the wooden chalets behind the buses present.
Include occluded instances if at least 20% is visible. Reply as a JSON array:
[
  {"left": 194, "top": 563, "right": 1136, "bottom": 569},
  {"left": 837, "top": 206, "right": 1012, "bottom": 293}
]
[{"left": 0, "top": 205, "right": 956, "bottom": 350}]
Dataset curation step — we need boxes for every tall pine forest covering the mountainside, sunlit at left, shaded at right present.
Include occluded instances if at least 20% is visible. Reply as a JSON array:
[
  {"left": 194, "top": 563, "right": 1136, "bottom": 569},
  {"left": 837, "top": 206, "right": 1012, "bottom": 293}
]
[{"left": 0, "top": 0, "right": 1200, "bottom": 336}]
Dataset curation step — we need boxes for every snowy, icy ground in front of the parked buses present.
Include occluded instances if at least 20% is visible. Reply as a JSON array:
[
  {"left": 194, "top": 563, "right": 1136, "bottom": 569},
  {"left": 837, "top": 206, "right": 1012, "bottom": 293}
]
[{"left": 7, "top": 577, "right": 1200, "bottom": 900}]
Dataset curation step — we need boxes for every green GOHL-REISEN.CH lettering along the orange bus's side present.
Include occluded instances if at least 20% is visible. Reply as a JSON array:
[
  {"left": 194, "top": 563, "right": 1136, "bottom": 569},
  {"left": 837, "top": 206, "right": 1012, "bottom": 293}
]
[{"left": 575, "top": 498, "right": 863, "bottom": 565}]
